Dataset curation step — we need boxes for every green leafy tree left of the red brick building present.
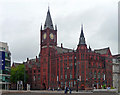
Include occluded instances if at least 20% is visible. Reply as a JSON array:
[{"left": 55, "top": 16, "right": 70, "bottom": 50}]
[{"left": 10, "top": 64, "right": 28, "bottom": 83}]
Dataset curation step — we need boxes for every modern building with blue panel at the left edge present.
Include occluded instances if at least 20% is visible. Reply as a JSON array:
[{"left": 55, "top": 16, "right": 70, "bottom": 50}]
[{"left": 0, "top": 42, "right": 11, "bottom": 90}]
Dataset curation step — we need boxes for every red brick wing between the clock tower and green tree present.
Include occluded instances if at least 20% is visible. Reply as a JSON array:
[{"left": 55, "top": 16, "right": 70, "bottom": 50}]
[{"left": 24, "top": 57, "right": 41, "bottom": 90}]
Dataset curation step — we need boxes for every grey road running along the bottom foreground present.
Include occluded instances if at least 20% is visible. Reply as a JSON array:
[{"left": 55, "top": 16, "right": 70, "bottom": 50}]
[{"left": 2, "top": 91, "right": 119, "bottom": 95}]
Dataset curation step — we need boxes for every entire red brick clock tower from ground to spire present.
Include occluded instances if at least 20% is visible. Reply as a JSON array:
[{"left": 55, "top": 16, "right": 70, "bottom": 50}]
[{"left": 40, "top": 8, "right": 57, "bottom": 89}]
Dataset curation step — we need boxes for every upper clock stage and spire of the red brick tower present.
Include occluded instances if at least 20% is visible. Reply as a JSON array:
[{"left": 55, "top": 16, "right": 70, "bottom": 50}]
[{"left": 40, "top": 8, "right": 57, "bottom": 50}]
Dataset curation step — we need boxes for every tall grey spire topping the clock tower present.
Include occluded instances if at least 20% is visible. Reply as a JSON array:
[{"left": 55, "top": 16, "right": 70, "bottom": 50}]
[{"left": 44, "top": 6, "right": 54, "bottom": 29}]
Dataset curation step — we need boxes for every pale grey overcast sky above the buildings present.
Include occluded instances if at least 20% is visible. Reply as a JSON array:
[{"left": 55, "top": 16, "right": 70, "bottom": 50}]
[{"left": 0, "top": 0, "right": 119, "bottom": 62}]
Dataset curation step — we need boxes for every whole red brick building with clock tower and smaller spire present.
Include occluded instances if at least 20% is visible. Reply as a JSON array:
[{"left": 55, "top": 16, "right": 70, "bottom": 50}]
[{"left": 25, "top": 9, "right": 112, "bottom": 89}]
